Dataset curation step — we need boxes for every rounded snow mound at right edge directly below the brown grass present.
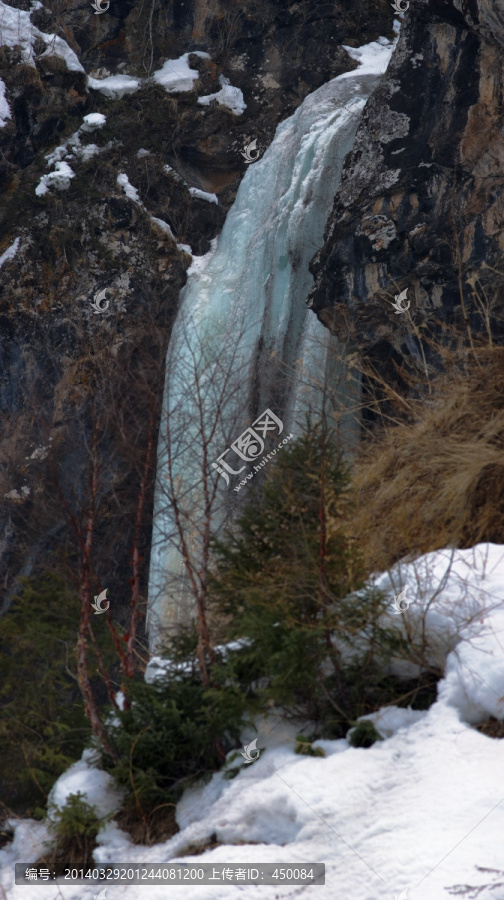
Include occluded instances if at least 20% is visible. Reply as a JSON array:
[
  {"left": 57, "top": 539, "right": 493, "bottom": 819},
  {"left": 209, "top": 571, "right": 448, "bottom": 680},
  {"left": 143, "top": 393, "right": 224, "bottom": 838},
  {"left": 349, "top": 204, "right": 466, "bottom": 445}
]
[{"left": 373, "top": 544, "right": 504, "bottom": 724}]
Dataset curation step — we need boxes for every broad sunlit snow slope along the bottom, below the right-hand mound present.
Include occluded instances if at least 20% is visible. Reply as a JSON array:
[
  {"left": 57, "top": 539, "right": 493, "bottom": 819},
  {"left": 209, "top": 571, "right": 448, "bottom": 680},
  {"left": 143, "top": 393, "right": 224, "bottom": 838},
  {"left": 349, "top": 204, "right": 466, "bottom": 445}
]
[{"left": 87, "top": 704, "right": 504, "bottom": 900}]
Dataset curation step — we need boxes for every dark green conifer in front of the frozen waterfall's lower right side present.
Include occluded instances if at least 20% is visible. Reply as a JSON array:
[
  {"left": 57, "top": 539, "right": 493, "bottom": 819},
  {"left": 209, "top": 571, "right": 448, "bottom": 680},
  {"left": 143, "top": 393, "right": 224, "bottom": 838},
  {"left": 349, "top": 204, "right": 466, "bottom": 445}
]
[{"left": 209, "top": 420, "right": 414, "bottom": 737}]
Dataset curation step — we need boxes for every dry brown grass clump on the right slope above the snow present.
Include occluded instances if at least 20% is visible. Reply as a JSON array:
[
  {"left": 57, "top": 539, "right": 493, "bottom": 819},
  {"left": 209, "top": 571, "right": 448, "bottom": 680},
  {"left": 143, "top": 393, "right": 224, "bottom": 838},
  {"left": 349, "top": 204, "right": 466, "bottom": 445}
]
[{"left": 349, "top": 347, "right": 504, "bottom": 572}]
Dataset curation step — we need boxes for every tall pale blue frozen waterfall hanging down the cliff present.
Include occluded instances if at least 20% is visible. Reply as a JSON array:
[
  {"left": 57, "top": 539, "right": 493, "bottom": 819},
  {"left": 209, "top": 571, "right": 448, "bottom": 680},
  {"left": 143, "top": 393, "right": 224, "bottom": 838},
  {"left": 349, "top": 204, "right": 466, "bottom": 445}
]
[{"left": 148, "top": 38, "right": 393, "bottom": 649}]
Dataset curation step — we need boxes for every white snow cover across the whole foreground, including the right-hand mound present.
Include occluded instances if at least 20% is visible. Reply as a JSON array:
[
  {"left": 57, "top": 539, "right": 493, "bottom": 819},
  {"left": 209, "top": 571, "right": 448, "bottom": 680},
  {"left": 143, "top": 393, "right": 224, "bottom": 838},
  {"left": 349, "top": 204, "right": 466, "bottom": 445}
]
[{"left": 0, "top": 544, "right": 504, "bottom": 900}]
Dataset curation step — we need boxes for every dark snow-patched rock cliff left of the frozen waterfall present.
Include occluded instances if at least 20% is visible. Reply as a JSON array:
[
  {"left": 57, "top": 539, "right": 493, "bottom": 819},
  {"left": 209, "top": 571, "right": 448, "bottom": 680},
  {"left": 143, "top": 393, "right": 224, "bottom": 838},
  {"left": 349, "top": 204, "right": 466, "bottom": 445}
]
[{"left": 0, "top": 0, "right": 394, "bottom": 620}]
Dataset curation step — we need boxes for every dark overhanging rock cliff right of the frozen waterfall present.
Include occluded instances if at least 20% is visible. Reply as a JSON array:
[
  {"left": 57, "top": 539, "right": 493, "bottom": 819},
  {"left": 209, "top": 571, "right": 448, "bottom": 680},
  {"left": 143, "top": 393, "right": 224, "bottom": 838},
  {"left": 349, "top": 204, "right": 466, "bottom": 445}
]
[{"left": 308, "top": 0, "right": 504, "bottom": 414}]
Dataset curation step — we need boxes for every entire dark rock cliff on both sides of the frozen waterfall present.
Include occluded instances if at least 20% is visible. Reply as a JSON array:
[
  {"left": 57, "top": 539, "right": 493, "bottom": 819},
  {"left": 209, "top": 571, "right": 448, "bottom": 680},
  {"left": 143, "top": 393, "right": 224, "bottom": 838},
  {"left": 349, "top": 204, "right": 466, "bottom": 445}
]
[{"left": 5, "top": 0, "right": 504, "bottom": 618}]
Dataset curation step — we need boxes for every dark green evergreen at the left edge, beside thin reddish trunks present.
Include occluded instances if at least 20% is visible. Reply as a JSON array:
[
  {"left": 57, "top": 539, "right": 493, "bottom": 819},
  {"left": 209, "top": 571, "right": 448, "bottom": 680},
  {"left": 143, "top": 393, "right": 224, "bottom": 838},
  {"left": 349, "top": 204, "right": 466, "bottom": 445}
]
[{"left": 0, "top": 571, "right": 90, "bottom": 817}]
